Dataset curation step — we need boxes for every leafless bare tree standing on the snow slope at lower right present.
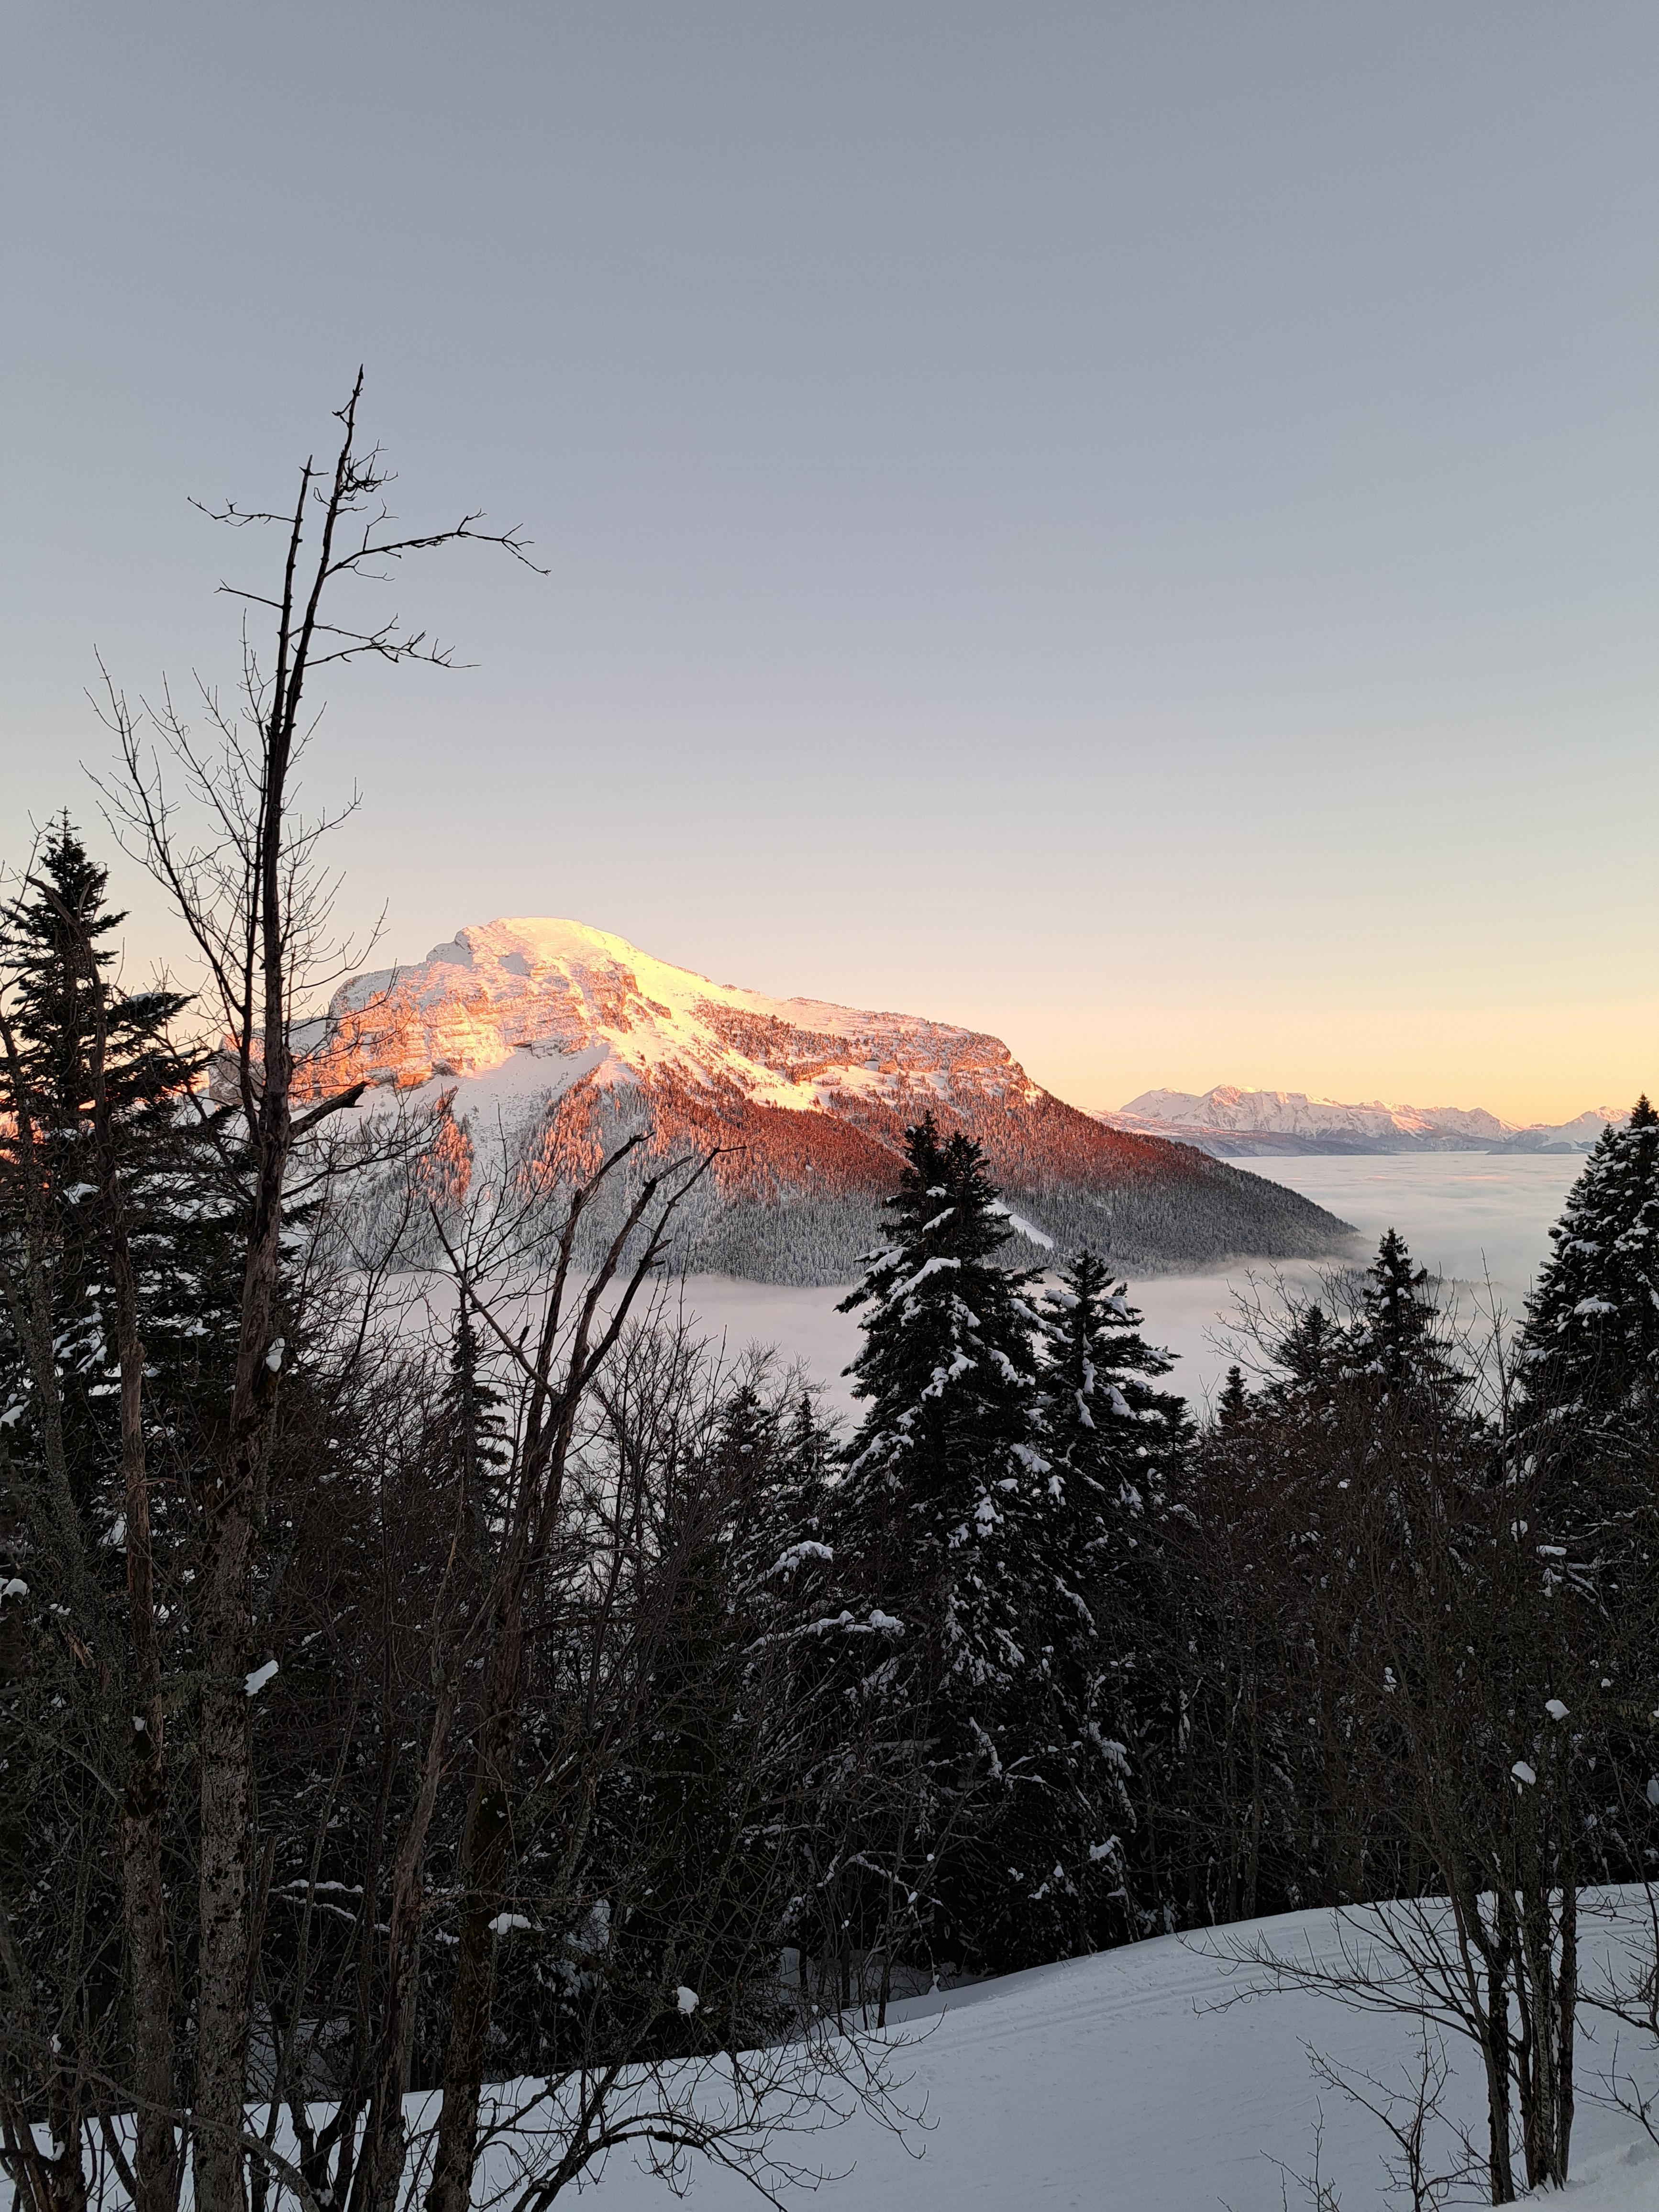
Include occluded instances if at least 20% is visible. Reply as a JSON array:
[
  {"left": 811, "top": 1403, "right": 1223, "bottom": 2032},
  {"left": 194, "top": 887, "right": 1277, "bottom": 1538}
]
[{"left": 1185, "top": 1265, "right": 1617, "bottom": 2203}]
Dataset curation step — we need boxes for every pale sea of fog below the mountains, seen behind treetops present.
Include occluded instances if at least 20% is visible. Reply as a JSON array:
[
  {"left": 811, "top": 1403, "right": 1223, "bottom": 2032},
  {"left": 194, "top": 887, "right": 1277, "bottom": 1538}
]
[{"left": 686, "top": 1152, "right": 1584, "bottom": 1409}]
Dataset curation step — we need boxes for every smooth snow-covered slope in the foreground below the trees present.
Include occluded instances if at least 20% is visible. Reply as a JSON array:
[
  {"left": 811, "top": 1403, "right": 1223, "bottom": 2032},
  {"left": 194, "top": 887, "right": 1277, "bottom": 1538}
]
[{"left": 493, "top": 1913, "right": 1659, "bottom": 2212}]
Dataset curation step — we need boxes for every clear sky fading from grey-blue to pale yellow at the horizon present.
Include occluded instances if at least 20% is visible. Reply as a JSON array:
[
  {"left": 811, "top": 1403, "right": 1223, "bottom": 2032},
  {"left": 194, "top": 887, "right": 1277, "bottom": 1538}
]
[{"left": 0, "top": 0, "right": 1659, "bottom": 1121}]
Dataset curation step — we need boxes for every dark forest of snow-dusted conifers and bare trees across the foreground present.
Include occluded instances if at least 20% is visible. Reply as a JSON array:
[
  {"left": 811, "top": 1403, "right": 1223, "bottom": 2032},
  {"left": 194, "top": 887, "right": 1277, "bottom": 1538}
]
[{"left": 0, "top": 389, "right": 1659, "bottom": 2212}]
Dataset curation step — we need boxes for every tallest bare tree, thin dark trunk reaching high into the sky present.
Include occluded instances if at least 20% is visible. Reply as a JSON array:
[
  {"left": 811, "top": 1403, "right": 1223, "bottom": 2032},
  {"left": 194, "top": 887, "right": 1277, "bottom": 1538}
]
[{"left": 94, "top": 372, "right": 540, "bottom": 2212}]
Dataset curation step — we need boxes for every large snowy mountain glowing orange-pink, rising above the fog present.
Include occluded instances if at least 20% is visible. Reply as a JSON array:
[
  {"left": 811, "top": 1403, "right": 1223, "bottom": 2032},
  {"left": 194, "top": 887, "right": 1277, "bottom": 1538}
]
[{"left": 297, "top": 920, "right": 1347, "bottom": 1283}]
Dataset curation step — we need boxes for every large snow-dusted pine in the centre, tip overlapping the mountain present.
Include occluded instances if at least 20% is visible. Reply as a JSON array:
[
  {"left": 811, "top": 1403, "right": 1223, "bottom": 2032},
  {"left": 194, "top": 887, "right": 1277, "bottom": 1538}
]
[{"left": 832, "top": 1115, "right": 1093, "bottom": 1967}]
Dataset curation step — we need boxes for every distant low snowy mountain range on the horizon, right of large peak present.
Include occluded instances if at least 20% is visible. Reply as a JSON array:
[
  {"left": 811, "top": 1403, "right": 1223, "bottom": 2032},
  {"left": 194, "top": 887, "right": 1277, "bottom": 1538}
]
[{"left": 1099, "top": 1084, "right": 1619, "bottom": 1159}]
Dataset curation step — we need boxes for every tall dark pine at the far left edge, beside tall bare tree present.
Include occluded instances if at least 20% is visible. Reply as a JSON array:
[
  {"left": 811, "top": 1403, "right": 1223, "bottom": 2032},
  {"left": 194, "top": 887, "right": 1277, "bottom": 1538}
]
[{"left": 0, "top": 816, "right": 237, "bottom": 2203}]
